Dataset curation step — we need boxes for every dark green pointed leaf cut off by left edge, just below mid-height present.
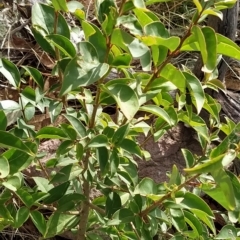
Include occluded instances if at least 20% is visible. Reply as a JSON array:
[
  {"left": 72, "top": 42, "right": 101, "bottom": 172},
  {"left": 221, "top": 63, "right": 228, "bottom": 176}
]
[{"left": 0, "top": 130, "right": 35, "bottom": 156}]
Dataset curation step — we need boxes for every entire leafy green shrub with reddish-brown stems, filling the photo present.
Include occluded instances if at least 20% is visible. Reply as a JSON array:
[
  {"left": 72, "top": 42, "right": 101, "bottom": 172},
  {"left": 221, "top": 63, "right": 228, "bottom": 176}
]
[{"left": 0, "top": 0, "right": 240, "bottom": 240}]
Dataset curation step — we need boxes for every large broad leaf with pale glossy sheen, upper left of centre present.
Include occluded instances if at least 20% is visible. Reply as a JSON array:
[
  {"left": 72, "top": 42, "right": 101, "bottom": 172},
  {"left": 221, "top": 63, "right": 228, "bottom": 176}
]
[{"left": 60, "top": 57, "right": 109, "bottom": 96}]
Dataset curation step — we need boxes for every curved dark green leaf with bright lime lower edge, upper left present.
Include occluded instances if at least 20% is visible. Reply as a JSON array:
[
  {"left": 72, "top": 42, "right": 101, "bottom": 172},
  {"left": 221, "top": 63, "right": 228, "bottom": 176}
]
[{"left": 46, "top": 34, "right": 77, "bottom": 58}]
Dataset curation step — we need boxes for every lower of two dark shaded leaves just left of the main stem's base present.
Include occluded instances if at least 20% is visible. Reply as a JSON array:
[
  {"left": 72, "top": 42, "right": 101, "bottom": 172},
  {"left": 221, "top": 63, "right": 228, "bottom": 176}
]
[{"left": 43, "top": 182, "right": 70, "bottom": 204}]
